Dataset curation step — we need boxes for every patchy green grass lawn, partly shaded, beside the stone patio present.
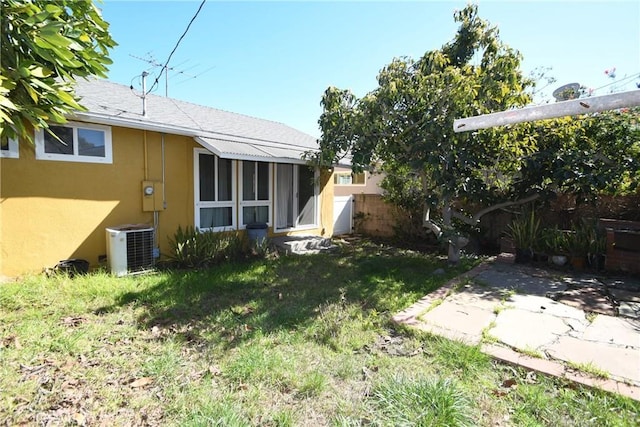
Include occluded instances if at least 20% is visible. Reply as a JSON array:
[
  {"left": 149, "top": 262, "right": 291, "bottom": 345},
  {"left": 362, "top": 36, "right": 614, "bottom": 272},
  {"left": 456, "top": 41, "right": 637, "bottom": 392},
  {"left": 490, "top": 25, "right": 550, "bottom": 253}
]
[{"left": 0, "top": 239, "right": 640, "bottom": 426}]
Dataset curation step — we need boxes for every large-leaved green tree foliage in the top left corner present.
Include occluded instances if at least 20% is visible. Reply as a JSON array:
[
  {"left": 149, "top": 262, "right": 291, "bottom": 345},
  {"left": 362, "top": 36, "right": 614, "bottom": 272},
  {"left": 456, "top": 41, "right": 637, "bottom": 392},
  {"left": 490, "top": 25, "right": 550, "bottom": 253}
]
[{"left": 0, "top": 0, "right": 116, "bottom": 141}]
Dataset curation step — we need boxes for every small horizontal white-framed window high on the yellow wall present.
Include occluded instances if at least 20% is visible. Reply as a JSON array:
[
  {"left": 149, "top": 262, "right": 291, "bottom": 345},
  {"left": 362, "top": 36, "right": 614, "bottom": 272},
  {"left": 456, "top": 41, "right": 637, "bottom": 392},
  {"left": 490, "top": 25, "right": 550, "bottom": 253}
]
[{"left": 36, "top": 122, "right": 113, "bottom": 164}]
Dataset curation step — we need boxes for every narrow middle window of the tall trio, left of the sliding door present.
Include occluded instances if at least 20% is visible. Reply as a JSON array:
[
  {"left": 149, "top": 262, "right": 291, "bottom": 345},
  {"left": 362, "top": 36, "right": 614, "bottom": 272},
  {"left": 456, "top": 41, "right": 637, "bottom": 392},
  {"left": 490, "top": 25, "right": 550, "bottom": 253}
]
[{"left": 240, "top": 160, "right": 272, "bottom": 228}]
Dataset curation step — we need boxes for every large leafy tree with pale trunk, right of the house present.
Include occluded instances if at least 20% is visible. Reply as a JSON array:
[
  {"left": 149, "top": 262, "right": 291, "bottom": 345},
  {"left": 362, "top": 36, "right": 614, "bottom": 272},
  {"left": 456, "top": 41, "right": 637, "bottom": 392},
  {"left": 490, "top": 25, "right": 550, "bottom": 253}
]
[{"left": 316, "top": 5, "right": 533, "bottom": 260}]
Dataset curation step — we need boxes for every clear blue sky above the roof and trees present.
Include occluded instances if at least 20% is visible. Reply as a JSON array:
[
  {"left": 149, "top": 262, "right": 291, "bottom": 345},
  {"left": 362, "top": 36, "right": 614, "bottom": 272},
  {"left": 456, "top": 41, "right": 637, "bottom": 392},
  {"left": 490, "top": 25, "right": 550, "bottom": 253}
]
[{"left": 98, "top": 0, "right": 640, "bottom": 137}]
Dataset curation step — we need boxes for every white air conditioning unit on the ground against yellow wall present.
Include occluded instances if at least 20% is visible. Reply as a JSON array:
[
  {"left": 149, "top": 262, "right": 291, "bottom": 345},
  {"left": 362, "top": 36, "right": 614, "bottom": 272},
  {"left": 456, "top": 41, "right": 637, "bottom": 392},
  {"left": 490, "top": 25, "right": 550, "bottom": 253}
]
[{"left": 106, "top": 224, "right": 154, "bottom": 276}]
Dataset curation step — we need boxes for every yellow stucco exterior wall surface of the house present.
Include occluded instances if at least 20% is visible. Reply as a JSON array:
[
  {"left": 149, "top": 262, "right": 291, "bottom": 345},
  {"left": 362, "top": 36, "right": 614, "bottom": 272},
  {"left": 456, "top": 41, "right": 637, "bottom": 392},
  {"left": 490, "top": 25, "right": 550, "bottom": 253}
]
[{"left": 0, "top": 127, "right": 333, "bottom": 276}]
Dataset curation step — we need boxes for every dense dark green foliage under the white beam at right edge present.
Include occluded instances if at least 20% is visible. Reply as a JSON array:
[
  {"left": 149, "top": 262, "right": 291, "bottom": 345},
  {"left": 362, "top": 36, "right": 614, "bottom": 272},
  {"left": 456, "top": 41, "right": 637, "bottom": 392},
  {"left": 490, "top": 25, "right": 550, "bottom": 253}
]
[{"left": 519, "top": 108, "right": 640, "bottom": 201}]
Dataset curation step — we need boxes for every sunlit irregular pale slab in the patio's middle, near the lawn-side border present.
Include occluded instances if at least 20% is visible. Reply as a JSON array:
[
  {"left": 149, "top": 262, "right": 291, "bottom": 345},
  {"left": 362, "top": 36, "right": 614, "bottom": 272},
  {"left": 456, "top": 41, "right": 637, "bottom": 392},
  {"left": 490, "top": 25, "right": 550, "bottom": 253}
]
[{"left": 489, "top": 309, "right": 570, "bottom": 350}]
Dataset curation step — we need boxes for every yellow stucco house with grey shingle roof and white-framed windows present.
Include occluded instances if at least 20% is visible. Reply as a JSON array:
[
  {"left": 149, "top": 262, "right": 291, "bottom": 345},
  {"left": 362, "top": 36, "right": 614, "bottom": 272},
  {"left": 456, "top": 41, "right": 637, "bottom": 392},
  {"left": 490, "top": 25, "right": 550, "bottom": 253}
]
[{"left": 0, "top": 80, "right": 333, "bottom": 277}]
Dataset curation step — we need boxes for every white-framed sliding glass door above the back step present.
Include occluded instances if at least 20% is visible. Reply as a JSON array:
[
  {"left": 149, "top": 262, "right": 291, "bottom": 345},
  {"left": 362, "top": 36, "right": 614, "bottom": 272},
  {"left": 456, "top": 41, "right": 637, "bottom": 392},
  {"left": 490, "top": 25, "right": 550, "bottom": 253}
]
[{"left": 275, "top": 163, "right": 319, "bottom": 231}]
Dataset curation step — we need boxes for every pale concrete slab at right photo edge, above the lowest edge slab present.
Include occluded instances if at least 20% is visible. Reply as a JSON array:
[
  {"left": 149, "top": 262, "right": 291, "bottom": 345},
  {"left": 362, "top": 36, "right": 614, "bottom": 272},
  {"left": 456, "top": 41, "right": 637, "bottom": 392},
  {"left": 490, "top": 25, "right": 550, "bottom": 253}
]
[{"left": 582, "top": 315, "right": 640, "bottom": 348}]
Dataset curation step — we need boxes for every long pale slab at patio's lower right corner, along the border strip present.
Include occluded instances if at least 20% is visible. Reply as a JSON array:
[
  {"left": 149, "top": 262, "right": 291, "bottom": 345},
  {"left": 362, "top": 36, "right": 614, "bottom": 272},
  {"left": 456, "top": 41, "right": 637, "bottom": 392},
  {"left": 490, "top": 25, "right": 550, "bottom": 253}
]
[{"left": 546, "top": 336, "right": 640, "bottom": 385}]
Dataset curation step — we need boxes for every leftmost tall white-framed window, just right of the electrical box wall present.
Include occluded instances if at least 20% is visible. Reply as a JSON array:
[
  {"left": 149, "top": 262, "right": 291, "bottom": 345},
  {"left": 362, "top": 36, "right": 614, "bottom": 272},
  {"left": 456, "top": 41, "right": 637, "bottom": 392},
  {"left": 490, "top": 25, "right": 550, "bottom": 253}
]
[{"left": 193, "top": 148, "right": 236, "bottom": 231}]
